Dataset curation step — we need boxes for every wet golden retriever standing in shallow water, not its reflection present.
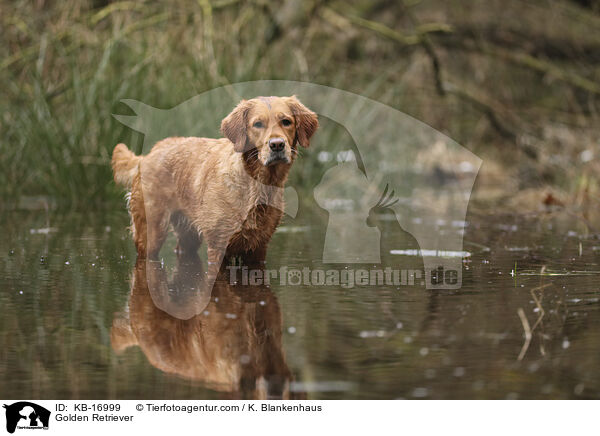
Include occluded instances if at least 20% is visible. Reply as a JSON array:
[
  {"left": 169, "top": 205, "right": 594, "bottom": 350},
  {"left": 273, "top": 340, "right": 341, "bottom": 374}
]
[{"left": 112, "top": 96, "right": 319, "bottom": 265}]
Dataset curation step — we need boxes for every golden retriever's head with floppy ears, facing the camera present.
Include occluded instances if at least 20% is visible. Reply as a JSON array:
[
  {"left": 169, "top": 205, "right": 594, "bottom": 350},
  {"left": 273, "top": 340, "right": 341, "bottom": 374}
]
[{"left": 221, "top": 96, "right": 319, "bottom": 166}]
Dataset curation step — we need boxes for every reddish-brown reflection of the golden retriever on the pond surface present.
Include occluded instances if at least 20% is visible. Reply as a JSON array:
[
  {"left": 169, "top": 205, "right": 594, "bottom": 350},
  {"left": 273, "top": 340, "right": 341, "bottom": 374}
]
[{"left": 111, "top": 257, "right": 302, "bottom": 399}]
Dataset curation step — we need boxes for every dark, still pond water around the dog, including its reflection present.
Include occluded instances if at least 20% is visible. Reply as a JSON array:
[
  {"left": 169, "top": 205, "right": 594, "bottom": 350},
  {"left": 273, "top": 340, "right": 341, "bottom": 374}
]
[{"left": 0, "top": 208, "right": 600, "bottom": 399}]
